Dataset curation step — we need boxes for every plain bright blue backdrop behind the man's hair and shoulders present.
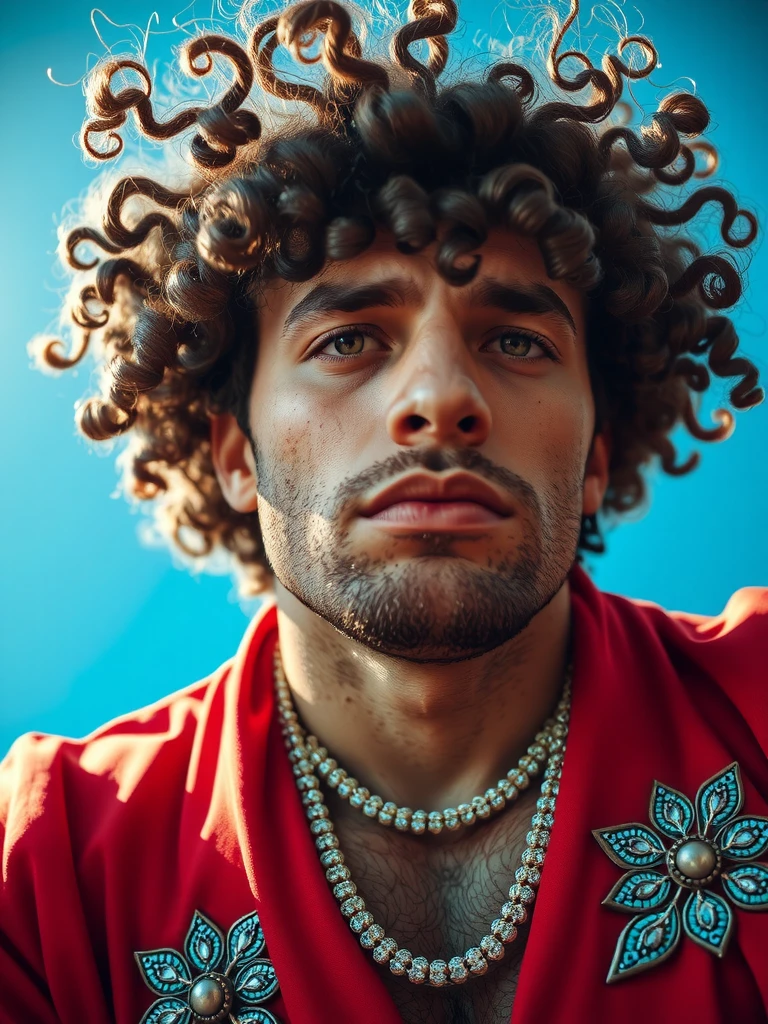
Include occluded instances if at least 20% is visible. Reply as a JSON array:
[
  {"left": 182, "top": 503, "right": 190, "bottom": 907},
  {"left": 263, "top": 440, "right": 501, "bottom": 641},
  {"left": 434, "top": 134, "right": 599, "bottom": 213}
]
[{"left": 0, "top": 0, "right": 768, "bottom": 755}]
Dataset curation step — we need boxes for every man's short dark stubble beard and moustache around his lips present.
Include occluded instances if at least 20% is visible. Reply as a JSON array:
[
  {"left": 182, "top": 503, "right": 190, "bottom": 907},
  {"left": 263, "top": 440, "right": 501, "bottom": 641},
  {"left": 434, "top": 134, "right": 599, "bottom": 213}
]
[{"left": 254, "top": 450, "right": 583, "bottom": 664}]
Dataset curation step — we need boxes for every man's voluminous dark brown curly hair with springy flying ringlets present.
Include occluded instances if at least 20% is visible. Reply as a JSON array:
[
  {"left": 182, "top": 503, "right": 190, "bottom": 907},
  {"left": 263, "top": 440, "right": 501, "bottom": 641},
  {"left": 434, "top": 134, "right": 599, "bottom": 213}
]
[{"left": 33, "top": 0, "right": 763, "bottom": 593}]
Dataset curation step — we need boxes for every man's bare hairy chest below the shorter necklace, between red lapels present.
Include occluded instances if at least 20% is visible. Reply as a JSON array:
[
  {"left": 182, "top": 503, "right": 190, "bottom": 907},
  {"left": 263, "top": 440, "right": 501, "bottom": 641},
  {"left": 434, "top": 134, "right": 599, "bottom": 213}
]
[{"left": 330, "top": 785, "right": 539, "bottom": 1024}]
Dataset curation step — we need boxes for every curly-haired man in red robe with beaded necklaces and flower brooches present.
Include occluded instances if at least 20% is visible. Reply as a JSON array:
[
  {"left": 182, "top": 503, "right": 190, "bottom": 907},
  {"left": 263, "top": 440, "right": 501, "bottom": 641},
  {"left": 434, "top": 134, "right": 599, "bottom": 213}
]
[{"left": 0, "top": 0, "right": 768, "bottom": 1024}]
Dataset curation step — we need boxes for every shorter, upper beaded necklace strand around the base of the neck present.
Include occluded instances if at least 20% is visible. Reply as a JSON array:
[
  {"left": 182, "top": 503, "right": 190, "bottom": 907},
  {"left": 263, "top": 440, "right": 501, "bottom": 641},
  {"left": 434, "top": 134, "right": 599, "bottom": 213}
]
[{"left": 274, "top": 646, "right": 570, "bottom": 836}]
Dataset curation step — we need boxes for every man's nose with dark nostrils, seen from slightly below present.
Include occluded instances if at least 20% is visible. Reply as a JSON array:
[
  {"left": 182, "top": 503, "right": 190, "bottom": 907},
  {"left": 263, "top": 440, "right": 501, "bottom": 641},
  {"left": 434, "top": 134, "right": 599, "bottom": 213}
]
[{"left": 387, "top": 330, "right": 490, "bottom": 447}]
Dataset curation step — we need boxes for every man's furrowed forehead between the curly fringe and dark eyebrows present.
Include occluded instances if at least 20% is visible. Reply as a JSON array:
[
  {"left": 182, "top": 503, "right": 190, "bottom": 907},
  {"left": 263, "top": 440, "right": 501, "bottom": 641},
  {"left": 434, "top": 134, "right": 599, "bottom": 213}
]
[{"left": 255, "top": 228, "right": 585, "bottom": 328}]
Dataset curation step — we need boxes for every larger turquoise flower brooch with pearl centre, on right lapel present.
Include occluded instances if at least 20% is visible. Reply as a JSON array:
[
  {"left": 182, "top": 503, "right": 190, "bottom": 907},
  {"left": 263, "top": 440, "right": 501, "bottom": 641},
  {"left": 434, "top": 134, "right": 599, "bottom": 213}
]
[{"left": 593, "top": 761, "right": 768, "bottom": 982}]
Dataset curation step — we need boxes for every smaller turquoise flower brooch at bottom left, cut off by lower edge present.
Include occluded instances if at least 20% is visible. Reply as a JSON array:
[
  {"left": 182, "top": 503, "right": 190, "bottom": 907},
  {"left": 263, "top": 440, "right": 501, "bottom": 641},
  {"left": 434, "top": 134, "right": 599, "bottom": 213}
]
[{"left": 133, "top": 910, "right": 280, "bottom": 1024}]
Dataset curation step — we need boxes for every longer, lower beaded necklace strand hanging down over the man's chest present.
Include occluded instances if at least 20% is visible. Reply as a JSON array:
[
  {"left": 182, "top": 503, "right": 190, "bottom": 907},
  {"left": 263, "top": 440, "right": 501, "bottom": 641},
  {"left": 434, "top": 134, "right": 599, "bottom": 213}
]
[{"left": 275, "top": 649, "right": 570, "bottom": 988}]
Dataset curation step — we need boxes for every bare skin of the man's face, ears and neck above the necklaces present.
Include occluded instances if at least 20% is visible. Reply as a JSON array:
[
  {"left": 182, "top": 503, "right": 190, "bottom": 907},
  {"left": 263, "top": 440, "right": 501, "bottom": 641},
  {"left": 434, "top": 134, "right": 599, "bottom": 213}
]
[{"left": 211, "top": 230, "right": 608, "bottom": 811}]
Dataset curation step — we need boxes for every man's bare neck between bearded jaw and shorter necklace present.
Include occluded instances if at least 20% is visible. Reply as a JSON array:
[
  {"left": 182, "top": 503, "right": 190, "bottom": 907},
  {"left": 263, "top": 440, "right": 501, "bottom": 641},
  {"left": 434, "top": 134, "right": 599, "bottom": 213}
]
[{"left": 275, "top": 581, "right": 570, "bottom": 810}]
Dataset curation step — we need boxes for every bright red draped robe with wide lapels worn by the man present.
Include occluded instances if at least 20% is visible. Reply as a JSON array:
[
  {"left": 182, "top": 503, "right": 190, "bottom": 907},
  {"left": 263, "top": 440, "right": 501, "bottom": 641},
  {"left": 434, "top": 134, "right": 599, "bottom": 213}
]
[{"left": 0, "top": 568, "right": 768, "bottom": 1024}]
